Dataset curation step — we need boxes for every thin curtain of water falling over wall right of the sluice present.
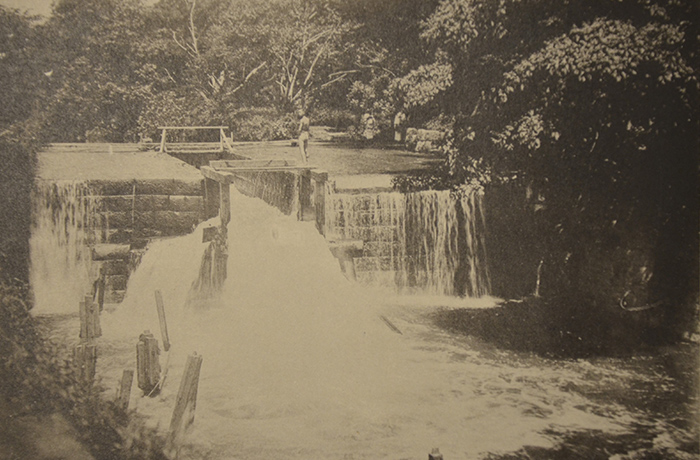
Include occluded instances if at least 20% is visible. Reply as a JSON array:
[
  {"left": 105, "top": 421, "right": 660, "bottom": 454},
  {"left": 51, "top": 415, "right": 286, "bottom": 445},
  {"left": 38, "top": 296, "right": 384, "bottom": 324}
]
[{"left": 326, "top": 187, "right": 490, "bottom": 297}]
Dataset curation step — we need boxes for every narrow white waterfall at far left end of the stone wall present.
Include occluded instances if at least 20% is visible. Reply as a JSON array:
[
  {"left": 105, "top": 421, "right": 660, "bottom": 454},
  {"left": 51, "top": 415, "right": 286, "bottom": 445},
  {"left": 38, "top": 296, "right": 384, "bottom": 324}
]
[{"left": 30, "top": 181, "right": 101, "bottom": 313}]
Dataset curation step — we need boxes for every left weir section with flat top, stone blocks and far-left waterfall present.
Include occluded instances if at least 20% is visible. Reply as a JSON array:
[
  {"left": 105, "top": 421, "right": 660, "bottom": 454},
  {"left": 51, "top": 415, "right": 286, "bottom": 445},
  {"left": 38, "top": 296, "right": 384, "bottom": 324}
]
[{"left": 31, "top": 144, "right": 204, "bottom": 305}]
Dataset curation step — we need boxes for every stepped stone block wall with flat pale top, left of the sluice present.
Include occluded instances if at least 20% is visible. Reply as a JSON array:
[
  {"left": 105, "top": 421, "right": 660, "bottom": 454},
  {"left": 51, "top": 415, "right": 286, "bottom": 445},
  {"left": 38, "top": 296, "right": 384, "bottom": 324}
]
[{"left": 34, "top": 144, "right": 204, "bottom": 302}]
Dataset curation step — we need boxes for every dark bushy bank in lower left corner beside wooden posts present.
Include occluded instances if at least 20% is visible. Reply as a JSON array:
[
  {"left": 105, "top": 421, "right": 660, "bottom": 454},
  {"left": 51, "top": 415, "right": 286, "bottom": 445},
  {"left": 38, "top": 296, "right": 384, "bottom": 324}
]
[{"left": 0, "top": 284, "right": 165, "bottom": 460}]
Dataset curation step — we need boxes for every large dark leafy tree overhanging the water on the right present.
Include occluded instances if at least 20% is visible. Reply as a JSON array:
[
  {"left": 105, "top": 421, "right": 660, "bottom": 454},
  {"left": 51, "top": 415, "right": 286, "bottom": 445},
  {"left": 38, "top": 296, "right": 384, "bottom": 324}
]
[{"left": 424, "top": 0, "right": 699, "bottom": 338}]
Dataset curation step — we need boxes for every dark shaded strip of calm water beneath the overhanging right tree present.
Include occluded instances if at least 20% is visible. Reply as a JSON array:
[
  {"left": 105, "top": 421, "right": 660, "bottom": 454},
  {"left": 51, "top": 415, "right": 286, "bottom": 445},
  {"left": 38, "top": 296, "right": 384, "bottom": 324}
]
[{"left": 433, "top": 297, "right": 696, "bottom": 358}]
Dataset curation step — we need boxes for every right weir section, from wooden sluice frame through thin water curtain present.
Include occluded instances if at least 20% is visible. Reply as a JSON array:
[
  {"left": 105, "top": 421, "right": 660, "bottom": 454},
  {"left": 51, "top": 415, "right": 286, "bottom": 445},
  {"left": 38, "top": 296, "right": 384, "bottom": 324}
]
[{"left": 201, "top": 160, "right": 490, "bottom": 297}]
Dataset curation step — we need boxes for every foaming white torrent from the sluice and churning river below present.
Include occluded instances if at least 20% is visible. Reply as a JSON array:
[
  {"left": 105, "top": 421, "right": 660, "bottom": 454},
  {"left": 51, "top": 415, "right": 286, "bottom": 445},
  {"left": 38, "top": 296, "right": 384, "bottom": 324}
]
[{"left": 31, "top": 191, "right": 697, "bottom": 459}]
